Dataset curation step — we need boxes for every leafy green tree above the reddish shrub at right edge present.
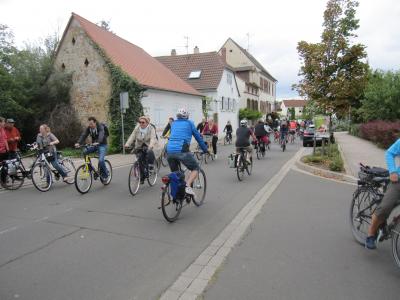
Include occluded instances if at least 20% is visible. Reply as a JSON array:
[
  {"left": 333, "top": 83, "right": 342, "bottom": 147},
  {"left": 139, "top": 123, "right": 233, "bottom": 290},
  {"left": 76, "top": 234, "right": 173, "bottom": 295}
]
[{"left": 358, "top": 70, "right": 400, "bottom": 122}]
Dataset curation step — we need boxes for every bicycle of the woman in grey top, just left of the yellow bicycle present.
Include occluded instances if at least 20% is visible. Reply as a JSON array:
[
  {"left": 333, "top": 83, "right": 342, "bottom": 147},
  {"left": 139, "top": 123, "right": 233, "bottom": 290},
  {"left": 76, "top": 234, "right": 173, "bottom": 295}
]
[{"left": 31, "top": 149, "right": 76, "bottom": 192}]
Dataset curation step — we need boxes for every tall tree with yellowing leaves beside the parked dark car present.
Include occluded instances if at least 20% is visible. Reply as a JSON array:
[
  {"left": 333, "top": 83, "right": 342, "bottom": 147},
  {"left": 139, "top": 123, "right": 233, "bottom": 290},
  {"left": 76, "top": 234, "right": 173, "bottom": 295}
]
[{"left": 293, "top": 0, "right": 368, "bottom": 131}]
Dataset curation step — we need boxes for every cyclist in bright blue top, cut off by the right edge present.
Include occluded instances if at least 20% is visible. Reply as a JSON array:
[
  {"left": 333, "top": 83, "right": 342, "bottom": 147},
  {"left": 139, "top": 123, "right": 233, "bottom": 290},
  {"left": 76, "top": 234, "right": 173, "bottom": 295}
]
[{"left": 365, "top": 139, "right": 400, "bottom": 249}]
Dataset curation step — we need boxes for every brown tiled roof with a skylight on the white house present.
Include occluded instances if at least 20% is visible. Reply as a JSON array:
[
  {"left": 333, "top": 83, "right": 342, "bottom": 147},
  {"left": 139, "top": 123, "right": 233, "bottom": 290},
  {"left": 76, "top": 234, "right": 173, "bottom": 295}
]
[{"left": 156, "top": 52, "right": 231, "bottom": 90}]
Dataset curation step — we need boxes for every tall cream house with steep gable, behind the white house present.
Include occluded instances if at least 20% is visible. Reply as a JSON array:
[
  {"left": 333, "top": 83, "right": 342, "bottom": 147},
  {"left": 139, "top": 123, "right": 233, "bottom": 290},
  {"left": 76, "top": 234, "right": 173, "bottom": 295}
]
[{"left": 219, "top": 38, "right": 277, "bottom": 115}]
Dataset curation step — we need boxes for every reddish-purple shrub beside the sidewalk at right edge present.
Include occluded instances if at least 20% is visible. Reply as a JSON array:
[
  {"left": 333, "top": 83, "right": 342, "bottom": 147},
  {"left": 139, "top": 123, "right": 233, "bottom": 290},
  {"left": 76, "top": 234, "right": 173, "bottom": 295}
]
[{"left": 359, "top": 120, "right": 400, "bottom": 148}]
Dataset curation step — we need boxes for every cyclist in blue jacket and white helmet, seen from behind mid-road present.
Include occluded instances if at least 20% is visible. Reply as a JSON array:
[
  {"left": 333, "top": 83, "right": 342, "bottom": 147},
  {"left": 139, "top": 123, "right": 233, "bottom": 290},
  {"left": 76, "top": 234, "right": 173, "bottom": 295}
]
[{"left": 167, "top": 108, "right": 208, "bottom": 196}]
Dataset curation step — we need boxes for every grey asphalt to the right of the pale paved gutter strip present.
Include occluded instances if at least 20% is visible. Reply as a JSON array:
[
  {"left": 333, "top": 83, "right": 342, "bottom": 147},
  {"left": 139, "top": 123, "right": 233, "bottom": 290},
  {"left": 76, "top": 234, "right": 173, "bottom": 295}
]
[{"left": 204, "top": 171, "right": 400, "bottom": 300}]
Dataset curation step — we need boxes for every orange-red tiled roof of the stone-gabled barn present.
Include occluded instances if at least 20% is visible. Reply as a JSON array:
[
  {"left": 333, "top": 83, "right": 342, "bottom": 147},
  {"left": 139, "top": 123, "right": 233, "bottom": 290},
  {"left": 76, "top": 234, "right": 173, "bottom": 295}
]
[{"left": 71, "top": 13, "right": 200, "bottom": 95}]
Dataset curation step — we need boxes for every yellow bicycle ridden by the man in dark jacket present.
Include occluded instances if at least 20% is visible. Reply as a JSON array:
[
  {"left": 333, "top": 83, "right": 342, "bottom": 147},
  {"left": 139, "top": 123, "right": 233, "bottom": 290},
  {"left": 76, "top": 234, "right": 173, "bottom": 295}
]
[{"left": 75, "top": 144, "right": 112, "bottom": 194}]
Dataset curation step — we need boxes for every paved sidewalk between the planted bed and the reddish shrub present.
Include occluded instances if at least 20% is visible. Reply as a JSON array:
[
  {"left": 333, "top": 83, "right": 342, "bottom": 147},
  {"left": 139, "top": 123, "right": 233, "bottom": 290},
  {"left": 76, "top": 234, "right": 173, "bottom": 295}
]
[{"left": 335, "top": 132, "right": 386, "bottom": 177}]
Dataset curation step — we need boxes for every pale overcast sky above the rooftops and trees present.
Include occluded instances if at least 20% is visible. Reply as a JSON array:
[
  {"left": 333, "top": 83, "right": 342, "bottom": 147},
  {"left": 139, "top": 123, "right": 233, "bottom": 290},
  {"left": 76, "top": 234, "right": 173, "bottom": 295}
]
[{"left": 0, "top": 0, "right": 400, "bottom": 99}]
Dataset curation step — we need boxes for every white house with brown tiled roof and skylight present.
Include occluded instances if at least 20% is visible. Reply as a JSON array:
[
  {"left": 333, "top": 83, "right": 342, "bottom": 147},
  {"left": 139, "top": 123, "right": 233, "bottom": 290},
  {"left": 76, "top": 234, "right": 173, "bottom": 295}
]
[{"left": 157, "top": 47, "right": 240, "bottom": 137}]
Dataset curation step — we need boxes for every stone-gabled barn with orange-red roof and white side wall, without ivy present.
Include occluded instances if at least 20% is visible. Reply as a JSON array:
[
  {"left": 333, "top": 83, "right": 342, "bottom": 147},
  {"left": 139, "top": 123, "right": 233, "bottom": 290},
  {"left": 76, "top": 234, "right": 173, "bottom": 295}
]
[{"left": 55, "top": 14, "right": 202, "bottom": 130}]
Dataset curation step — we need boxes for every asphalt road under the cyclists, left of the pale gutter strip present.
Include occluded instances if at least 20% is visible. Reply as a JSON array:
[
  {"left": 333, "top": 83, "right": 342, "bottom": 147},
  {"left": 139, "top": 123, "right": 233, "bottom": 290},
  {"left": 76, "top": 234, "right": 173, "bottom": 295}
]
[{"left": 0, "top": 141, "right": 299, "bottom": 300}]
